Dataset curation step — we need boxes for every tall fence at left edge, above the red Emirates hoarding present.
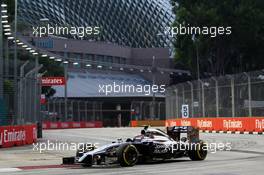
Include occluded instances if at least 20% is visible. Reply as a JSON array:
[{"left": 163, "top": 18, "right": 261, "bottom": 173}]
[{"left": 0, "top": 75, "right": 41, "bottom": 126}]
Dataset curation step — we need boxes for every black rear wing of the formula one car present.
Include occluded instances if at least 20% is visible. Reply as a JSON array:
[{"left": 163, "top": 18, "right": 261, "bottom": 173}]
[{"left": 167, "top": 126, "right": 200, "bottom": 142}]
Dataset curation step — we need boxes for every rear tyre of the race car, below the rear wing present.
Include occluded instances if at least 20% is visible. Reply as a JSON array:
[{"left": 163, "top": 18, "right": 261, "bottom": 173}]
[{"left": 188, "top": 141, "right": 207, "bottom": 161}]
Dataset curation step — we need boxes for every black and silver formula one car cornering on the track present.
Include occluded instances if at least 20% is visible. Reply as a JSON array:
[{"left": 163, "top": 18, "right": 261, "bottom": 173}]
[{"left": 63, "top": 126, "right": 207, "bottom": 167}]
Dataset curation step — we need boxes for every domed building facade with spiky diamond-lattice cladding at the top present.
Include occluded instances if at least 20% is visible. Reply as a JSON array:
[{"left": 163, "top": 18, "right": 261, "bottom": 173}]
[{"left": 18, "top": 0, "right": 174, "bottom": 48}]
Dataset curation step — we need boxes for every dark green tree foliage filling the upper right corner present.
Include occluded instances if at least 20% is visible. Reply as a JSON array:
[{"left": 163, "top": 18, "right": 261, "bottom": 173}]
[{"left": 171, "top": 0, "right": 264, "bottom": 76}]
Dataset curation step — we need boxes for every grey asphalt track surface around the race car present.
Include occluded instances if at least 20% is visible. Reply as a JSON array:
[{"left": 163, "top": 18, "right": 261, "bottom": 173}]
[{"left": 0, "top": 128, "right": 264, "bottom": 175}]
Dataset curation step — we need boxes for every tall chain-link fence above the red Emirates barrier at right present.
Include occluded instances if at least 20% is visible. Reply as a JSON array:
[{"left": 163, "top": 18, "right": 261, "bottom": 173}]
[{"left": 166, "top": 70, "right": 264, "bottom": 119}]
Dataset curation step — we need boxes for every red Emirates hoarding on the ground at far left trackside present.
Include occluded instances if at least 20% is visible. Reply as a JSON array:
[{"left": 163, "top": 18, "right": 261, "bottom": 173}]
[{"left": 0, "top": 125, "right": 37, "bottom": 148}]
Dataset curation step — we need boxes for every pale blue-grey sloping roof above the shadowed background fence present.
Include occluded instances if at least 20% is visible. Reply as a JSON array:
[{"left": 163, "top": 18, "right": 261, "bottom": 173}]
[{"left": 53, "top": 72, "right": 164, "bottom": 98}]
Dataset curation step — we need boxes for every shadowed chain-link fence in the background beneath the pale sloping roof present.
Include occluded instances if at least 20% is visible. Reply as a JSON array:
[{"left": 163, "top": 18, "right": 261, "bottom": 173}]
[{"left": 41, "top": 98, "right": 165, "bottom": 126}]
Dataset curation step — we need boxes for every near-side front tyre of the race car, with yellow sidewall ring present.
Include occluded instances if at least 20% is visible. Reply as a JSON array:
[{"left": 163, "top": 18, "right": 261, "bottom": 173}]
[{"left": 117, "top": 144, "right": 138, "bottom": 167}]
